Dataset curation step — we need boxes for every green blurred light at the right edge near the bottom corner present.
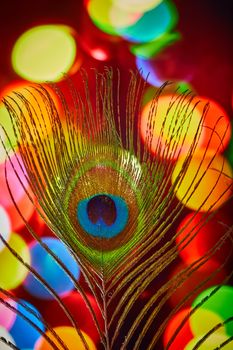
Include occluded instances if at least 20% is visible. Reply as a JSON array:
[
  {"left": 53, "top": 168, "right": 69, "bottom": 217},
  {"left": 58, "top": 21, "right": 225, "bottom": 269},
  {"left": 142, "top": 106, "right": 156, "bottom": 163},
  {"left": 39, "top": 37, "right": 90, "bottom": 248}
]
[{"left": 193, "top": 285, "right": 233, "bottom": 336}]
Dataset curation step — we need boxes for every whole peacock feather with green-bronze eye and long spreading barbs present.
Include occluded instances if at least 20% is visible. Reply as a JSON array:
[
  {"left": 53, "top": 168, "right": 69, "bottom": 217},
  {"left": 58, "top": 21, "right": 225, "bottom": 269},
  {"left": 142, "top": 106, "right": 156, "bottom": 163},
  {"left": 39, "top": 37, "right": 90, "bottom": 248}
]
[{"left": 2, "top": 69, "right": 232, "bottom": 350}]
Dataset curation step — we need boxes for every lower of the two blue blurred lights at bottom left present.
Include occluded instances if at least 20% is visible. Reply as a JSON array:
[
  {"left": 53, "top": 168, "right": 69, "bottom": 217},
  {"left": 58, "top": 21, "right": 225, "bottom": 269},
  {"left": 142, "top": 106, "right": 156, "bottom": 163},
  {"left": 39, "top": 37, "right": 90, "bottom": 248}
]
[{"left": 10, "top": 300, "right": 45, "bottom": 349}]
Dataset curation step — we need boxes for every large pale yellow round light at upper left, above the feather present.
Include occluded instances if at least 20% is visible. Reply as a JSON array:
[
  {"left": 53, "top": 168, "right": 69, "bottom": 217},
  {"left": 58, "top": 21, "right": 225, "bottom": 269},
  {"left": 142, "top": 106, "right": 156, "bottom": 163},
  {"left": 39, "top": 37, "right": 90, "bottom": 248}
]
[{"left": 12, "top": 25, "right": 77, "bottom": 82}]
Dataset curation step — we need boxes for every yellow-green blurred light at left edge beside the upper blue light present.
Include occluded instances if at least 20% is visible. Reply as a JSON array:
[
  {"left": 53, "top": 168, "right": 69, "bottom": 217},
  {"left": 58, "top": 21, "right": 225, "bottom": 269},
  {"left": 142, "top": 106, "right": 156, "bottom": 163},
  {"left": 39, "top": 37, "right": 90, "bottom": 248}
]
[{"left": 0, "top": 233, "right": 30, "bottom": 290}]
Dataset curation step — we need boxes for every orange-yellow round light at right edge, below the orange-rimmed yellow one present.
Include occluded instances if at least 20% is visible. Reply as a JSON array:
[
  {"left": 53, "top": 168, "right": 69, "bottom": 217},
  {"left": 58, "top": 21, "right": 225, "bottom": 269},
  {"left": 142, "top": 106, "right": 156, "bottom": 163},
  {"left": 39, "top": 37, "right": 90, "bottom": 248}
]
[{"left": 172, "top": 152, "right": 232, "bottom": 212}]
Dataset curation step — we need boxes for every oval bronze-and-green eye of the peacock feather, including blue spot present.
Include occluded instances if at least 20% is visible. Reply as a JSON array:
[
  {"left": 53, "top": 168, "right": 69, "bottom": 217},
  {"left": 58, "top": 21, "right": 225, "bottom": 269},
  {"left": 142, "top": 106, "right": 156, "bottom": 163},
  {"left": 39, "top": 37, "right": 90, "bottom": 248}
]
[{"left": 63, "top": 146, "right": 145, "bottom": 273}]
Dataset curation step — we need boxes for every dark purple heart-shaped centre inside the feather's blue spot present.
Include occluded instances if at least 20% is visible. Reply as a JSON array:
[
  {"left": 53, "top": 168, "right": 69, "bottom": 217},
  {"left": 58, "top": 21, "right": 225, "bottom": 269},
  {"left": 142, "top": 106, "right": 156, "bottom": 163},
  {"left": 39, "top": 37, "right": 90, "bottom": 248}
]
[{"left": 87, "top": 194, "right": 117, "bottom": 226}]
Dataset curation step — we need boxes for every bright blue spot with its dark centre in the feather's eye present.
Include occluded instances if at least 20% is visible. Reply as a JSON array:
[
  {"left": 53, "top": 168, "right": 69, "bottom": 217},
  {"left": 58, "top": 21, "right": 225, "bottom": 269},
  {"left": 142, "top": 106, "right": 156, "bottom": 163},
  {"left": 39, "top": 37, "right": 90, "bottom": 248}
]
[{"left": 77, "top": 194, "right": 129, "bottom": 238}]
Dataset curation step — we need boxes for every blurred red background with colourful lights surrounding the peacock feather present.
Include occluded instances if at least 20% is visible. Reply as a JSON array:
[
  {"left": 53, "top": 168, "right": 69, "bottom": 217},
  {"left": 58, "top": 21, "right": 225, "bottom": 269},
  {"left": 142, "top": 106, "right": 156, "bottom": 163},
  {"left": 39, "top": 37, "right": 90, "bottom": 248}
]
[{"left": 0, "top": 0, "right": 233, "bottom": 350}]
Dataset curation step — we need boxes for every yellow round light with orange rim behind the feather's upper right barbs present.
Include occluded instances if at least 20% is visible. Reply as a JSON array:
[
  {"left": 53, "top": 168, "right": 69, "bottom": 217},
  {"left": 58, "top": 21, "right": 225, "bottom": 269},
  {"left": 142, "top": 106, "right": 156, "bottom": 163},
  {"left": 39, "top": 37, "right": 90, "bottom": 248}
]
[{"left": 140, "top": 95, "right": 201, "bottom": 159}]
